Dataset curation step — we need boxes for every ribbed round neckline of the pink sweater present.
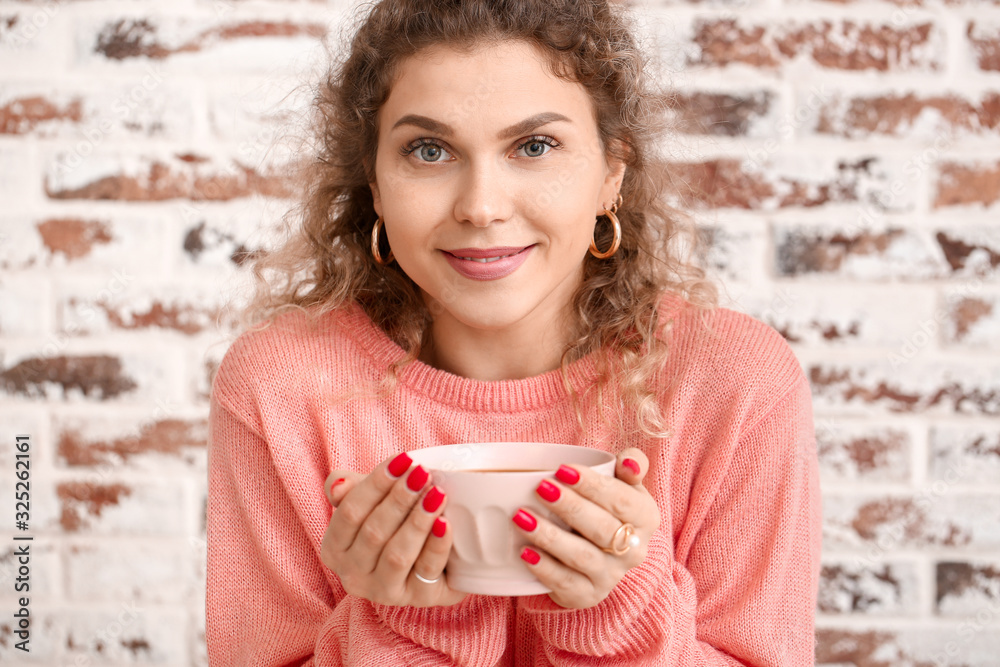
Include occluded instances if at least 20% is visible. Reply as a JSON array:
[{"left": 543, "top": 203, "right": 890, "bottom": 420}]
[{"left": 340, "top": 302, "right": 600, "bottom": 412}]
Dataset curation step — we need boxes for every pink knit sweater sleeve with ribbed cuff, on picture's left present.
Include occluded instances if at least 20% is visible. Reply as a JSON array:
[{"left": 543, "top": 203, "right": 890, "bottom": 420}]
[{"left": 205, "top": 352, "right": 513, "bottom": 667}]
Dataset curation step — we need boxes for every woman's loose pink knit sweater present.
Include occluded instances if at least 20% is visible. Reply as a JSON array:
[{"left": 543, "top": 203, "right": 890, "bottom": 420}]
[{"left": 206, "top": 297, "right": 820, "bottom": 667}]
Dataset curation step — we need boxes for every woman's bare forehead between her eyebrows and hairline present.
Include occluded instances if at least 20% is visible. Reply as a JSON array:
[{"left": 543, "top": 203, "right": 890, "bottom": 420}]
[{"left": 379, "top": 41, "right": 596, "bottom": 132}]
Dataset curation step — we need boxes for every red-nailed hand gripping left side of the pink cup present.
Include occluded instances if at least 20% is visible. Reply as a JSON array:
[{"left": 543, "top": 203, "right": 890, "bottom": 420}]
[{"left": 320, "top": 453, "right": 466, "bottom": 607}]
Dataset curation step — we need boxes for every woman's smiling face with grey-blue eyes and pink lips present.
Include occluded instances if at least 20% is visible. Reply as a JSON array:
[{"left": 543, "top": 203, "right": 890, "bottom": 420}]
[{"left": 371, "top": 42, "right": 624, "bottom": 330}]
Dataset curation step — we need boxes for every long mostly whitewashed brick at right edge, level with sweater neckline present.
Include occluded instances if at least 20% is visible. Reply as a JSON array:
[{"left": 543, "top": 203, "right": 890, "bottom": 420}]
[{"left": 808, "top": 362, "right": 1000, "bottom": 416}]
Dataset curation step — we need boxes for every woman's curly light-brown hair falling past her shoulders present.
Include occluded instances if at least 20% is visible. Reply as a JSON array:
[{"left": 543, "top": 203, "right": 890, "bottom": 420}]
[{"left": 242, "top": 0, "right": 717, "bottom": 437}]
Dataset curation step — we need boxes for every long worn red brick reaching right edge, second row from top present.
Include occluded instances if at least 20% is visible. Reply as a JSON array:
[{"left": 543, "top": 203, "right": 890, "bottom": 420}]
[{"left": 816, "top": 93, "right": 1000, "bottom": 138}]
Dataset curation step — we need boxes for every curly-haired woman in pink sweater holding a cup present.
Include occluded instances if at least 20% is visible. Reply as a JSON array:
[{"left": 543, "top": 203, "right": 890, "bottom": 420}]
[{"left": 206, "top": 0, "right": 820, "bottom": 667}]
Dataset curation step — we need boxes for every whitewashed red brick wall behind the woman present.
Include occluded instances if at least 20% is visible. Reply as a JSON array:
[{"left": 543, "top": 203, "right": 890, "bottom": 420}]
[{"left": 0, "top": 0, "right": 1000, "bottom": 667}]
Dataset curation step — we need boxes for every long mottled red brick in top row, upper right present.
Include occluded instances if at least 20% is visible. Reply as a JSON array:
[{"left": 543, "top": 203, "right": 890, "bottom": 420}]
[{"left": 692, "top": 18, "right": 943, "bottom": 71}]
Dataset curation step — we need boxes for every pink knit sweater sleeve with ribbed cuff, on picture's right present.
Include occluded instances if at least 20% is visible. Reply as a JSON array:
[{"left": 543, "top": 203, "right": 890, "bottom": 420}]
[{"left": 519, "top": 375, "right": 821, "bottom": 667}]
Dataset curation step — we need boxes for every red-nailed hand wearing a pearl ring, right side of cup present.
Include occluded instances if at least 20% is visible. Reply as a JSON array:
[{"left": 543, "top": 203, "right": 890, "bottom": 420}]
[{"left": 513, "top": 449, "right": 660, "bottom": 609}]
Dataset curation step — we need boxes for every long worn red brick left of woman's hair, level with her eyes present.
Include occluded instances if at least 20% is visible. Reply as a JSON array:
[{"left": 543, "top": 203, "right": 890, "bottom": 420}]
[{"left": 45, "top": 153, "right": 294, "bottom": 201}]
